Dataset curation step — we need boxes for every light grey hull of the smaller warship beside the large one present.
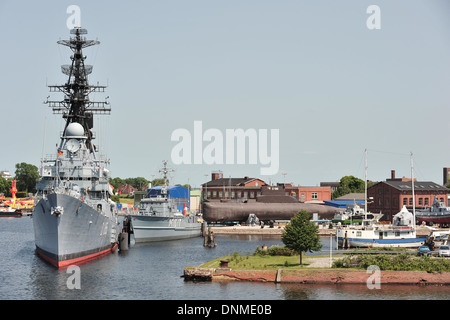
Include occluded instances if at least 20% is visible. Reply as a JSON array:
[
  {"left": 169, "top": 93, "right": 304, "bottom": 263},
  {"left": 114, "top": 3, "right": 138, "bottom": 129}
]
[{"left": 130, "top": 215, "right": 202, "bottom": 243}]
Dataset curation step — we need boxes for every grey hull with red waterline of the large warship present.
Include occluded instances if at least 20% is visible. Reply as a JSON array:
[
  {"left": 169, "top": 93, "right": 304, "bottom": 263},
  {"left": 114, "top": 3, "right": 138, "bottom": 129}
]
[{"left": 33, "top": 193, "right": 117, "bottom": 268}]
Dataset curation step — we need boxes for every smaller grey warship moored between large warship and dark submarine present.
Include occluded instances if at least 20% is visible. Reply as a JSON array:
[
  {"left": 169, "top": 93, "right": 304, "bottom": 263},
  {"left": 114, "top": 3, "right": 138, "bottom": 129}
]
[{"left": 128, "top": 161, "right": 203, "bottom": 243}]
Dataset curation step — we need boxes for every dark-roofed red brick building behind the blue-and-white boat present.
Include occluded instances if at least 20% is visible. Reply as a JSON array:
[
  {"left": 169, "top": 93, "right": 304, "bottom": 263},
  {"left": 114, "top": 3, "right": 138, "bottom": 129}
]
[{"left": 367, "top": 170, "right": 448, "bottom": 221}]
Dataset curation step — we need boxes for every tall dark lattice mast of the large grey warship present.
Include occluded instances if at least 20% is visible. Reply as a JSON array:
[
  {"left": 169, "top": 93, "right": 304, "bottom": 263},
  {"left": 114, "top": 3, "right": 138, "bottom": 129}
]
[{"left": 44, "top": 27, "right": 111, "bottom": 155}]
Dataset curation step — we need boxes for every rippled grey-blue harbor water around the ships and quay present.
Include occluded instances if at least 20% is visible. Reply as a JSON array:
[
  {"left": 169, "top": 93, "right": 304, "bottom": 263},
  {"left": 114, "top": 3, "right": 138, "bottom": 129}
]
[{"left": 0, "top": 217, "right": 450, "bottom": 300}]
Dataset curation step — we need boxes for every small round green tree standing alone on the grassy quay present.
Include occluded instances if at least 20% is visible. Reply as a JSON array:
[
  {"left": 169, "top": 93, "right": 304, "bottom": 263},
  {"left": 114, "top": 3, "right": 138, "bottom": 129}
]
[{"left": 281, "top": 210, "right": 322, "bottom": 265}]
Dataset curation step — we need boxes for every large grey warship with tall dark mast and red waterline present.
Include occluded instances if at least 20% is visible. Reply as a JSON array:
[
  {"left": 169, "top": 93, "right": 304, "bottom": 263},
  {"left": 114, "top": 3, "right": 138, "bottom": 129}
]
[{"left": 32, "top": 28, "right": 119, "bottom": 268}]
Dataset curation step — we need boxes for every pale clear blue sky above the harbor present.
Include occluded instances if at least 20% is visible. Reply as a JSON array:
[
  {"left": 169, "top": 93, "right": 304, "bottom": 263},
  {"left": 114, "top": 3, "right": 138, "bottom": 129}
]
[{"left": 0, "top": 0, "right": 450, "bottom": 186}]
